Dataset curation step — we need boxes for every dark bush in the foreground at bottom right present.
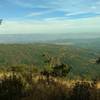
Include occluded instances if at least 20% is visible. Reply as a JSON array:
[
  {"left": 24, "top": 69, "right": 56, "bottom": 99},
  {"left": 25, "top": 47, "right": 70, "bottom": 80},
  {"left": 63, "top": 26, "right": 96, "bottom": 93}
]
[{"left": 71, "top": 82, "right": 91, "bottom": 100}]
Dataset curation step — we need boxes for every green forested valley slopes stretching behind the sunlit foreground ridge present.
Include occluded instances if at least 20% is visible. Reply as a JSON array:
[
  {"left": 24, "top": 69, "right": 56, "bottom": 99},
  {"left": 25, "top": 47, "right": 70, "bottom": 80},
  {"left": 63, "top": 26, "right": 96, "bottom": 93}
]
[{"left": 0, "top": 43, "right": 100, "bottom": 80}]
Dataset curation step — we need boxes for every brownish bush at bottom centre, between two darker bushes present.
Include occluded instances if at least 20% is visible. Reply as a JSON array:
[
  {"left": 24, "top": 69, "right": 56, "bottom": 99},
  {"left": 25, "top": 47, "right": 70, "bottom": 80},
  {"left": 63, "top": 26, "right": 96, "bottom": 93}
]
[{"left": 26, "top": 80, "right": 68, "bottom": 100}]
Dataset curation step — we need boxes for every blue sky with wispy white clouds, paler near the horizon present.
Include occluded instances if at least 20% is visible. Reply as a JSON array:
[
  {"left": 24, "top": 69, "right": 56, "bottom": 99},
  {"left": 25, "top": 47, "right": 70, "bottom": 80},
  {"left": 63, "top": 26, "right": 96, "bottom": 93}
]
[{"left": 0, "top": 0, "right": 100, "bottom": 34}]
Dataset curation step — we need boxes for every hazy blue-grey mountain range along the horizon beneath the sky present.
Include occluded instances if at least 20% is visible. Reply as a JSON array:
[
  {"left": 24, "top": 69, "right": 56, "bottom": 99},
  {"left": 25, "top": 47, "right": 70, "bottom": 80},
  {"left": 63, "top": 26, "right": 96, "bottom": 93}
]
[{"left": 0, "top": 34, "right": 100, "bottom": 43}]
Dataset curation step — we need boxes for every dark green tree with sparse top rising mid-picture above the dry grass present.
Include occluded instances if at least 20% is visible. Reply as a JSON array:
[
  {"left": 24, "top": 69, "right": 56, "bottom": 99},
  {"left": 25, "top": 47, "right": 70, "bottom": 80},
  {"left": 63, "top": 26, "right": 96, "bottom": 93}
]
[{"left": 41, "top": 54, "right": 72, "bottom": 84}]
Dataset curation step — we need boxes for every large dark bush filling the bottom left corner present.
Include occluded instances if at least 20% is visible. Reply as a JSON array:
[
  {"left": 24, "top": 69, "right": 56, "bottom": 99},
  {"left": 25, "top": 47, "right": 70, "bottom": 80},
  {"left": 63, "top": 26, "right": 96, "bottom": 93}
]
[{"left": 0, "top": 75, "right": 25, "bottom": 100}]
